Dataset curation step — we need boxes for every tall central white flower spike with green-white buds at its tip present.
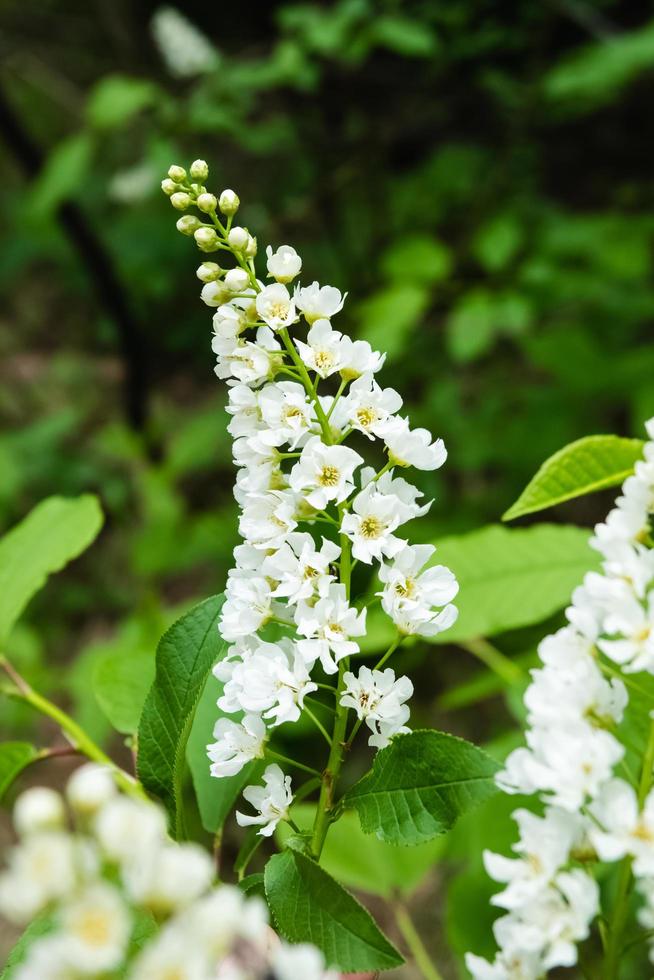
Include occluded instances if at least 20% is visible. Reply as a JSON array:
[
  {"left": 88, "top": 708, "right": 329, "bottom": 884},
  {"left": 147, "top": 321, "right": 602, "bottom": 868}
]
[{"left": 162, "top": 160, "right": 458, "bottom": 833}]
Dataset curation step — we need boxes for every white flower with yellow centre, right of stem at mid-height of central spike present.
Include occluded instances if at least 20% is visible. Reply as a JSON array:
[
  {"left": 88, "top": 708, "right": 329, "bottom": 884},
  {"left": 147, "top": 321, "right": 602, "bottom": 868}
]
[{"left": 341, "top": 483, "right": 406, "bottom": 565}]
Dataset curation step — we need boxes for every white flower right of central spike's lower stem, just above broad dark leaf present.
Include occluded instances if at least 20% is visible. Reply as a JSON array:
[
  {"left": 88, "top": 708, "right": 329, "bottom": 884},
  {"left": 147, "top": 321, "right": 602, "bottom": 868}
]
[{"left": 341, "top": 667, "right": 413, "bottom": 749}]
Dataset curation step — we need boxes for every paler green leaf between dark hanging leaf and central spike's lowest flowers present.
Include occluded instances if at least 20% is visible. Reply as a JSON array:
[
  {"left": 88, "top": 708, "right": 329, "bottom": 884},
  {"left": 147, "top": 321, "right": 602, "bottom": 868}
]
[{"left": 186, "top": 668, "right": 260, "bottom": 834}]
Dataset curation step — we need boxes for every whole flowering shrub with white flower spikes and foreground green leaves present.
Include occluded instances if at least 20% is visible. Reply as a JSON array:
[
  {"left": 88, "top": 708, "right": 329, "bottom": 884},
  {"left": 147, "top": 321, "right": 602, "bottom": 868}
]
[{"left": 0, "top": 160, "right": 654, "bottom": 980}]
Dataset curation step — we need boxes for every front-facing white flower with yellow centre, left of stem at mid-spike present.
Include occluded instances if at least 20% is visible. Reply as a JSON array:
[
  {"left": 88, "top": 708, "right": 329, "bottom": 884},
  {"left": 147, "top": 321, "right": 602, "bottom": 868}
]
[{"left": 289, "top": 436, "right": 363, "bottom": 510}]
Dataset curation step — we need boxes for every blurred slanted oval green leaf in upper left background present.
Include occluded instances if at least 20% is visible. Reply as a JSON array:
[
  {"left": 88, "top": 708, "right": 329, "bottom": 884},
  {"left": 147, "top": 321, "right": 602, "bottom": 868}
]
[{"left": 28, "top": 133, "right": 93, "bottom": 219}]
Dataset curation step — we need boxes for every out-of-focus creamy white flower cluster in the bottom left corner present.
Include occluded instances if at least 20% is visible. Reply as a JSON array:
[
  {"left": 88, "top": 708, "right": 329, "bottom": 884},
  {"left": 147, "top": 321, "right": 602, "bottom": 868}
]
[{"left": 0, "top": 764, "right": 336, "bottom": 980}]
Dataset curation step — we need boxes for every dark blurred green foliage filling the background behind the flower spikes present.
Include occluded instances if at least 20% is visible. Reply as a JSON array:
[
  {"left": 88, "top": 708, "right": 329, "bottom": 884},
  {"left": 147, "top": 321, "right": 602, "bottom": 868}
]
[{"left": 0, "top": 0, "right": 654, "bottom": 972}]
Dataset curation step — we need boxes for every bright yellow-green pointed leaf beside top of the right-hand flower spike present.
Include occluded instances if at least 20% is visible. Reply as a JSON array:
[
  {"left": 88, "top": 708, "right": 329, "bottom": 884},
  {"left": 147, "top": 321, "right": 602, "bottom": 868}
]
[{"left": 502, "top": 436, "right": 644, "bottom": 521}]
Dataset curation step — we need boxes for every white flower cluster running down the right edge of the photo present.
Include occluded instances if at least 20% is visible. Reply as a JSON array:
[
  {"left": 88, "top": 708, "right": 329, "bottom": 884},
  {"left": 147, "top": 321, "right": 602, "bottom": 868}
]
[{"left": 467, "top": 420, "right": 654, "bottom": 980}]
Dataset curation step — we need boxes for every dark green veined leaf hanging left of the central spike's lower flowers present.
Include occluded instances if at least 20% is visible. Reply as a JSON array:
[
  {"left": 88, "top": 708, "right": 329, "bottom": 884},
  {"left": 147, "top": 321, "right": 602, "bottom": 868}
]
[{"left": 138, "top": 595, "right": 224, "bottom": 837}]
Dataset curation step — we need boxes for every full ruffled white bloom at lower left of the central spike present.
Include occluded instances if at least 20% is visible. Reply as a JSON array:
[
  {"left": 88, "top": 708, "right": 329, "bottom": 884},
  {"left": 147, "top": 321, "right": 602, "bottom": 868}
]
[{"left": 214, "top": 639, "right": 317, "bottom": 725}]
